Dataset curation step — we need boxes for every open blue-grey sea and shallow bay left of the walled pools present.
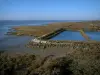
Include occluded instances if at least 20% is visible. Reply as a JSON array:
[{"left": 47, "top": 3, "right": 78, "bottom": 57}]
[{"left": 0, "top": 20, "right": 74, "bottom": 55}]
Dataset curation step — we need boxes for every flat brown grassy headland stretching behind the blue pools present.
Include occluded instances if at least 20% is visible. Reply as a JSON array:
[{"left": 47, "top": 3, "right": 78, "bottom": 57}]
[{"left": 8, "top": 21, "right": 100, "bottom": 36}]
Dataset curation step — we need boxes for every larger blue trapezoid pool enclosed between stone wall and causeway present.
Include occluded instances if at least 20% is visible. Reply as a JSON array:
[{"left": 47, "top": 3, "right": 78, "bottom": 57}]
[{"left": 52, "top": 31, "right": 85, "bottom": 40}]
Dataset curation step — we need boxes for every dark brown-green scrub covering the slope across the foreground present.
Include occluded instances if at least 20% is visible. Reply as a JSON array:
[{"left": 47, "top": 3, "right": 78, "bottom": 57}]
[{"left": 0, "top": 49, "right": 100, "bottom": 75}]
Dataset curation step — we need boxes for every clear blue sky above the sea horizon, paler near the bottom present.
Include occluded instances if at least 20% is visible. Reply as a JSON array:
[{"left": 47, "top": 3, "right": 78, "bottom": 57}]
[{"left": 0, "top": 0, "right": 100, "bottom": 20}]
